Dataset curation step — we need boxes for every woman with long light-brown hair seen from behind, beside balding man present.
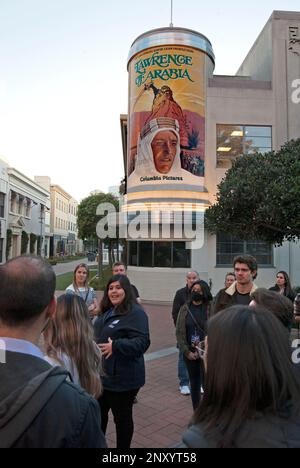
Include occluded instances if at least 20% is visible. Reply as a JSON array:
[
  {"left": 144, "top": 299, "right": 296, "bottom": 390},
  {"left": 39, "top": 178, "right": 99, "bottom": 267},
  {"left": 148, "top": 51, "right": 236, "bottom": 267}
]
[{"left": 44, "top": 294, "right": 102, "bottom": 398}]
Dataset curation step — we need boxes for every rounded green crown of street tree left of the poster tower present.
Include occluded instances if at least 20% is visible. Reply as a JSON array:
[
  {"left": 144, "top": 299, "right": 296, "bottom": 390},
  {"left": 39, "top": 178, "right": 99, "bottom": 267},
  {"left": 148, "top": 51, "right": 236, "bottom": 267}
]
[{"left": 77, "top": 193, "right": 119, "bottom": 240}]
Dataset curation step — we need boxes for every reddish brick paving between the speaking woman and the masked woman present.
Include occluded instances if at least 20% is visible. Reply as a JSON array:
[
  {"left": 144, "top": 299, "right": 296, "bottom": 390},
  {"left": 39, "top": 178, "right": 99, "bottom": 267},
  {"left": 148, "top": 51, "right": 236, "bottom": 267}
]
[{"left": 106, "top": 305, "right": 192, "bottom": 448}]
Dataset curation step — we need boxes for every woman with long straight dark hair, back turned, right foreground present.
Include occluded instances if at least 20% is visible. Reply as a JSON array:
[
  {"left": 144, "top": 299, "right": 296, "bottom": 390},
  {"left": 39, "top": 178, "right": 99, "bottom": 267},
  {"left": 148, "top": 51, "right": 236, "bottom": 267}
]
[{"left": 181, "top": 306, "right": 300, "bottom": 448}]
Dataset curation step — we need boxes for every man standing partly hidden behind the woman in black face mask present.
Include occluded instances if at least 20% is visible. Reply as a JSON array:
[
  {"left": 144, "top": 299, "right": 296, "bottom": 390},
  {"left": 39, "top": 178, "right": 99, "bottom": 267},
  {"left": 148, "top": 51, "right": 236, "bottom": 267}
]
[{"left": 172, "top": 271, "right": 199, "bottom": 395}]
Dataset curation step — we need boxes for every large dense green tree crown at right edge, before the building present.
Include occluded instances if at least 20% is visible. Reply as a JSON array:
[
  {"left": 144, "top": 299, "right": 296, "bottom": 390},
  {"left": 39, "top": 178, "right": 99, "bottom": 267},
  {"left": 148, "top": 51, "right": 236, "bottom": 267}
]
[{"left": 205, "top": 139, "right": 300, "bottom": 245}]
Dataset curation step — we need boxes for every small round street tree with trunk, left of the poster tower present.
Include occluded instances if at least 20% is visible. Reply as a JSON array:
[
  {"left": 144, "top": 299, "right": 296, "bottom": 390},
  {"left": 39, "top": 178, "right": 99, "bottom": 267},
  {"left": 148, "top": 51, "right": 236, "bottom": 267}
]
[{"left": 77, "top": 193, "right": 119, "bottom": 277}]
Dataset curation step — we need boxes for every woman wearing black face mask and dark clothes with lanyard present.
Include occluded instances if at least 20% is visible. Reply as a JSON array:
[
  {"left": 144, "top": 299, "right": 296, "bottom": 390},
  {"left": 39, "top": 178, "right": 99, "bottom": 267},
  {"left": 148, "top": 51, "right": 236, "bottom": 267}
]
[{"left": 176, "top": 281, "right": 212, "bottom": 410}]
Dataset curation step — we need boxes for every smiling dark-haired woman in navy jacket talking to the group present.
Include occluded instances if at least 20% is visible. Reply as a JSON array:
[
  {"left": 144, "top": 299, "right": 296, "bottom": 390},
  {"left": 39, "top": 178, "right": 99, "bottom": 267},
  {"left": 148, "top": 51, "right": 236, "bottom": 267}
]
[{"left": 94, "top": 275, "right": 150, "bottom": 449}]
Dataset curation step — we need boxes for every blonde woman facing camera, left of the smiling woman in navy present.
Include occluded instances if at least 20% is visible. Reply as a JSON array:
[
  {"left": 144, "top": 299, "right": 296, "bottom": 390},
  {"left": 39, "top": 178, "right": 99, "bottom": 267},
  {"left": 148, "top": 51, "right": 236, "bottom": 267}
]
[{"left": 66, "top": 263, "right": 100, "bottom": 320}]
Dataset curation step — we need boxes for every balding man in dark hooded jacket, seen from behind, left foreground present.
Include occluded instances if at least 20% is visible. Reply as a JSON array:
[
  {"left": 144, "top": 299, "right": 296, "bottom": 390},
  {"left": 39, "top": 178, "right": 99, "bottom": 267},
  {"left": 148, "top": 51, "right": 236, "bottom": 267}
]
[{"left": 0, "top": 256, "right": 106, "bottom": 448}]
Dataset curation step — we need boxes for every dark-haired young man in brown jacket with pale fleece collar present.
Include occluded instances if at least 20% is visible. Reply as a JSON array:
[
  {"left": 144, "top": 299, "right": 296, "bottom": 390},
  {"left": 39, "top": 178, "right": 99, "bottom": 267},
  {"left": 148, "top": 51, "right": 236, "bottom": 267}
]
[{"left": 212, "top": 255, "right": 258, "bottom": 315}]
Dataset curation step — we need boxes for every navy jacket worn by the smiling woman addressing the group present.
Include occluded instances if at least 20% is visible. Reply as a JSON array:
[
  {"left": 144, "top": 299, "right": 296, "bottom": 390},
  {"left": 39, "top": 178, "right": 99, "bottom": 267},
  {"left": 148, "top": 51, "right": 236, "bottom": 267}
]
[{"left": 94, "top": 304, "right": 150, "bottom": 392}]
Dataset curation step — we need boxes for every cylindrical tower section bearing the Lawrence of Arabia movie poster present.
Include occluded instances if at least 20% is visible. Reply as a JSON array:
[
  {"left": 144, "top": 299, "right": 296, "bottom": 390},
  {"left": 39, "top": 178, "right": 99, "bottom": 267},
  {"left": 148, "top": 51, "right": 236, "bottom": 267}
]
[{"left": 127, "top": 28, "right": 214, "bottom": 212}]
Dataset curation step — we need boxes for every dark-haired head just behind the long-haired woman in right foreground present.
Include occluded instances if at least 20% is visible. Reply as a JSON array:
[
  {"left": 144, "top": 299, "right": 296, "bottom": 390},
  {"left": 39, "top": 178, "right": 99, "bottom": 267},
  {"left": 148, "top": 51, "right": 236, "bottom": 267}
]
[{"left": 250, "top": 288, "right": 294, "bottom": 331}]
